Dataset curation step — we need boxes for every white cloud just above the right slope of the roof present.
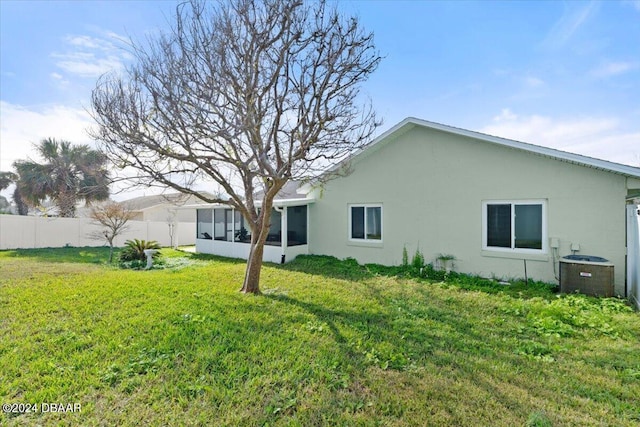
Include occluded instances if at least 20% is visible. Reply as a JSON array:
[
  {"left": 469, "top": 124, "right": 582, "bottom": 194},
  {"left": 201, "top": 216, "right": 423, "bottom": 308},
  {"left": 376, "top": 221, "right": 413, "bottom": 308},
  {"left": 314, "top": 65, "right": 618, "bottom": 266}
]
[{"left": 480, "top": 109, "right": 640, "bottom": 166}]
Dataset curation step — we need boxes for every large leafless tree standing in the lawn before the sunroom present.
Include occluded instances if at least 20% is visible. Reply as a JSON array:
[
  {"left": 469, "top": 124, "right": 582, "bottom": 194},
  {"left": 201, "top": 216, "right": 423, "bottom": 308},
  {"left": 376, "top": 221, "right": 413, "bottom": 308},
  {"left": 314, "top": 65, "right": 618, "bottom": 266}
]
[{"left": 92, "top": 0, "right": 381, "bottom": 293}]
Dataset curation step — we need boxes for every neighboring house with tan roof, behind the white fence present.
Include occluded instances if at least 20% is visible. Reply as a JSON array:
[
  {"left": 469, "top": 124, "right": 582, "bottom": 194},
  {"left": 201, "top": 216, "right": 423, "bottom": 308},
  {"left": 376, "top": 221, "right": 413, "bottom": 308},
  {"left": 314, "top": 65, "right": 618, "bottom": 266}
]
[{"left": 122, "top": 193, "right": 213, "bottom": 222}]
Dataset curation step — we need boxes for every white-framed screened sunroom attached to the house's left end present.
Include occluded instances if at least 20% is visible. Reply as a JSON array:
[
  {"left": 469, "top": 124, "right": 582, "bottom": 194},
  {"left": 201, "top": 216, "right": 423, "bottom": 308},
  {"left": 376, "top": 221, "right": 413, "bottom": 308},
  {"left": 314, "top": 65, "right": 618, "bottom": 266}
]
[{"left": 196, "top": 199, "right": 313, "bottom": 263}]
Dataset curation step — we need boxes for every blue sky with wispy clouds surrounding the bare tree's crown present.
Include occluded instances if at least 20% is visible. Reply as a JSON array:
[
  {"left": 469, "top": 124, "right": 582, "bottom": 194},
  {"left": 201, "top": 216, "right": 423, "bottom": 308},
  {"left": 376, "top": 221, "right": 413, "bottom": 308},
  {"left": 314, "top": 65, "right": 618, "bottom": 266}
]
[{"left": 0, "top": 0, "right": 640, "bottom": 199}]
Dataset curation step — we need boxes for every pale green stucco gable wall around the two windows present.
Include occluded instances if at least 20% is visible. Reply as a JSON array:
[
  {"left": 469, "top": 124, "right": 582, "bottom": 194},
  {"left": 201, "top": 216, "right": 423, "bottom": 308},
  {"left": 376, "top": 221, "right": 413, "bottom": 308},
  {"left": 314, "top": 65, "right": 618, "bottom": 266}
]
[{"left": 309, "top": 127, "right": 627, "bottom": 294}]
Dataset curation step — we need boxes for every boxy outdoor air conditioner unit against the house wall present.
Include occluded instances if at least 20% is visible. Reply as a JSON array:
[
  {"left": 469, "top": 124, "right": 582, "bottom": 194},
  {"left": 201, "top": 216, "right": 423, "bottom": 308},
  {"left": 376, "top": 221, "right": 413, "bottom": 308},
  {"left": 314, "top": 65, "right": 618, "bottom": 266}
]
[{"left": 560, "top": 255, "right": 614, "bottom": 297}]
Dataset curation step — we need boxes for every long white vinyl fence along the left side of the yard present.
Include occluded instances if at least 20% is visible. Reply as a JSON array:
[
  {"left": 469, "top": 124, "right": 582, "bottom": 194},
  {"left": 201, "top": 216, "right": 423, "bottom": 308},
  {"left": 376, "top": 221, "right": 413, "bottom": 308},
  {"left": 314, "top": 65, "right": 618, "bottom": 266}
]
[{"left": 0, "top": 215, "right": 196, "bottom": 249}]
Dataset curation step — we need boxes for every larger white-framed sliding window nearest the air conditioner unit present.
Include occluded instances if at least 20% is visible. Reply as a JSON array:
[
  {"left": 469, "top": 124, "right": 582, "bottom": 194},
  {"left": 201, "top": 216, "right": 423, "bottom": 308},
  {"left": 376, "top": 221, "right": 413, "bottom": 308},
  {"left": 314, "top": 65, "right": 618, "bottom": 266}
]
[{"left": 482, "top": 201, "right": 547, "bottom": 253}]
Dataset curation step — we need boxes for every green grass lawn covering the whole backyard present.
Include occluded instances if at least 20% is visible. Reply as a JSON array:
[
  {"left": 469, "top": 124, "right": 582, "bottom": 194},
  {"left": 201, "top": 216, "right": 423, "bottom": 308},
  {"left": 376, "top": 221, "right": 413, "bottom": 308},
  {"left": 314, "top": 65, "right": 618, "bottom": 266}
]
[{"left": 0, "top": 248, "right": 640, "bottom": 426}]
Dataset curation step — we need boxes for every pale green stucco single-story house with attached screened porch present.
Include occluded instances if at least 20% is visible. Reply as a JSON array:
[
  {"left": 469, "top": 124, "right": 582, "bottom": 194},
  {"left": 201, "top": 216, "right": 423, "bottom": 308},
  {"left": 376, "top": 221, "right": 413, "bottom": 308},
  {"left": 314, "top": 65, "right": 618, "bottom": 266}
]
[{"left": 197, "top": 118, "right": 640, "bottom": 295}]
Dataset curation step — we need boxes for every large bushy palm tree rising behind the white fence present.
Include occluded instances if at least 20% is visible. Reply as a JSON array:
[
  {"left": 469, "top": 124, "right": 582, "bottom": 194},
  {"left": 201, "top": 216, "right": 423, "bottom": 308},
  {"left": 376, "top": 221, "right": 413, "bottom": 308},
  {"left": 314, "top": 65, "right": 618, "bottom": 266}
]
[{"left": 13, "top": 138, "right": 109, "bottom": 218}]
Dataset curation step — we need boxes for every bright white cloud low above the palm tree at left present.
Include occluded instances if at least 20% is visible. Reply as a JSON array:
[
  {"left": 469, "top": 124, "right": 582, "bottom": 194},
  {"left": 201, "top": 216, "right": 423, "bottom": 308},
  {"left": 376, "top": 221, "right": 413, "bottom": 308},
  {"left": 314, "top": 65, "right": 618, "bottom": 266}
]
[{"left": 0, "top": 101, "right": 93, "bottom": 171}]
